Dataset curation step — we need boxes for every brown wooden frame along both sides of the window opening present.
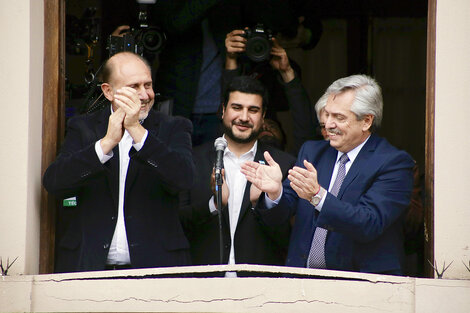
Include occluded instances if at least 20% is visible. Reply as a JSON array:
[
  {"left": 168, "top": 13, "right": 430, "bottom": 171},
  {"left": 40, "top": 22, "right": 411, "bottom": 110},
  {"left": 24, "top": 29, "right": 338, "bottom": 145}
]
[{"left": 39, "top": 0, "right": 437, "bottom": 277}]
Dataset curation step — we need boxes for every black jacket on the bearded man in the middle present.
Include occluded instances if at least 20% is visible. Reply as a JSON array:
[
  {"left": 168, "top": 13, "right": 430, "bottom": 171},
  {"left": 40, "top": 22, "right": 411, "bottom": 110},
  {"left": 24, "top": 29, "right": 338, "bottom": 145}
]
[{"left": 182, "top": 142, "right": 295, "bottom": 272}]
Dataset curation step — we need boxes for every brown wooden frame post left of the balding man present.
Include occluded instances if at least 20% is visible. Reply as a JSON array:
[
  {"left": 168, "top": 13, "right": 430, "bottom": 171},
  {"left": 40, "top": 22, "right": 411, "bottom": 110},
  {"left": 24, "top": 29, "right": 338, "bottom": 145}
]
[{"left": 39, "top": 0, "right": 65, "bottom": 274}]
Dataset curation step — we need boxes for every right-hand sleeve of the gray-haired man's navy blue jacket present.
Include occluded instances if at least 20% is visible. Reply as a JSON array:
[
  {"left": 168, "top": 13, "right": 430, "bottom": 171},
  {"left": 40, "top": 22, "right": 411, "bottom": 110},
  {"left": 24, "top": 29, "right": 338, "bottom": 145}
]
[{"left": 317, "top": 151, "right": 413, "bottom": 242}]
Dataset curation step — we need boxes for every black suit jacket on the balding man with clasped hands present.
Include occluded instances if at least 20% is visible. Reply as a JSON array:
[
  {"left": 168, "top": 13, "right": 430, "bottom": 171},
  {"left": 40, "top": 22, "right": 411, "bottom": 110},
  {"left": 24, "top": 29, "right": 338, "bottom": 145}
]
[{"left": 44, "top": 107, "right": 194, "bottom": 271}]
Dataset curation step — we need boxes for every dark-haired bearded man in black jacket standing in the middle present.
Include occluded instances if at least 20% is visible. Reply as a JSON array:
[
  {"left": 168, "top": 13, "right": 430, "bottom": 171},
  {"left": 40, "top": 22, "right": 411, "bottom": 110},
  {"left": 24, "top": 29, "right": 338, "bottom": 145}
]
[{"left": 181, "top": 76, "right": 295, "bottom": 276}]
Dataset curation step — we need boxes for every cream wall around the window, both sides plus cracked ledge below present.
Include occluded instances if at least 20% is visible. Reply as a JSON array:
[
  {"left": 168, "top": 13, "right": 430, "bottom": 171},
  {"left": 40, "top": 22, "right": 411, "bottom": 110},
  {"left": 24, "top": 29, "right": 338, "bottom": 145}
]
[{"left": 0, "top": 0, "right": 470, "bottom": 312}]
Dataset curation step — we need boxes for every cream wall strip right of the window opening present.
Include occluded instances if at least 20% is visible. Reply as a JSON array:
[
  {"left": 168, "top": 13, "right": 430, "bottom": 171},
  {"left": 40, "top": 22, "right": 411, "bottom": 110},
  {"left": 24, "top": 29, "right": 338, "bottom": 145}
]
[{"left": 434, "top": 0, "right": 470, "bottom": 279}]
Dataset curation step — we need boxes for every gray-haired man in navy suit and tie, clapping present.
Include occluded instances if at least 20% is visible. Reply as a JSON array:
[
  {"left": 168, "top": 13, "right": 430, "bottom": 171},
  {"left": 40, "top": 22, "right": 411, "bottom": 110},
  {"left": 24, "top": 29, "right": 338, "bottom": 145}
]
[{"left": 242, "top": 75, "right": 413, "bottom": 275}]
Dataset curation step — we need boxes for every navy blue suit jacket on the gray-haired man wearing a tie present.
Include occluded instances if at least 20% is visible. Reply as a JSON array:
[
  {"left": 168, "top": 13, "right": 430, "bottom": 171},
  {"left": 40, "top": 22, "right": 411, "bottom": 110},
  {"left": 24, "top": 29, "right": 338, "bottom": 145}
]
[{"left": 258, "top": 134, "right": 413, "bottom": 274}]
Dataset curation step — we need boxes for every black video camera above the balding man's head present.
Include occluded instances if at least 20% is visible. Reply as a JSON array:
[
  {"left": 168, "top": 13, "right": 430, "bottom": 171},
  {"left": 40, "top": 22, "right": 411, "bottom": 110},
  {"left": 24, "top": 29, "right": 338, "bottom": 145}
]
[{"left": 106, "top": 1, "right": 166, "bottom": 57}]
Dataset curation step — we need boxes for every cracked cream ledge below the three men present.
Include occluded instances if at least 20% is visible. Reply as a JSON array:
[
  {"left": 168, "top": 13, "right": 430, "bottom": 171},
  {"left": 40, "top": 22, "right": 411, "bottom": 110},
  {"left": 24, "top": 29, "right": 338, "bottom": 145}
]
[{"left": 0, "top": 265, "right": 470, "bottom": 313}]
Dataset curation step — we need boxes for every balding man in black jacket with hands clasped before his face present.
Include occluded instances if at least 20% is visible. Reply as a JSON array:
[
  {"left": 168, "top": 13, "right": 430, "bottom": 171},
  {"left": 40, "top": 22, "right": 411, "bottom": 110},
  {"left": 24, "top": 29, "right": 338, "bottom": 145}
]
[{"left": 44, "top": 52, "right": 194, "bottom": 271}]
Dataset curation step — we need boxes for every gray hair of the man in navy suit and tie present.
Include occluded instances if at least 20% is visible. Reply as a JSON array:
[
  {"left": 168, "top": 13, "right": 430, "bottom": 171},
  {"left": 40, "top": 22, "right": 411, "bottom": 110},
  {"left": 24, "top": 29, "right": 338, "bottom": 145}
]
[{"left": 315, "top": 75, "right": 383, "bottom": 130}]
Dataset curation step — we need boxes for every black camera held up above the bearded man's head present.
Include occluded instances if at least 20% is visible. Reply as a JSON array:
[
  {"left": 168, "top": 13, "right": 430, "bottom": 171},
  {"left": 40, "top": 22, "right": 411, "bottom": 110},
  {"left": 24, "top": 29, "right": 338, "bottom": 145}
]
[{"left": 244, "top": 24, "right": 273, "bottom": 62}]
